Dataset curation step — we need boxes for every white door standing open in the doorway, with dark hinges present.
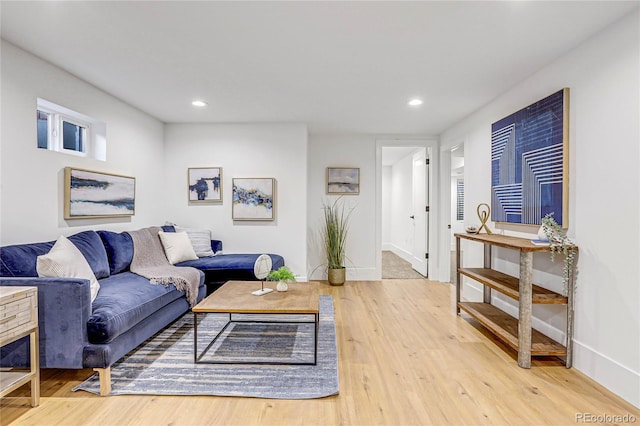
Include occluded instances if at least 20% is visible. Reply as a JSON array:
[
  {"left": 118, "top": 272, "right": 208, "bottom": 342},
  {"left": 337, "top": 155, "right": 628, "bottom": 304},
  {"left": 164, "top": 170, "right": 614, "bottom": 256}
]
[{"left": 410, "top": 148, "right": 429, "bottom": 277}]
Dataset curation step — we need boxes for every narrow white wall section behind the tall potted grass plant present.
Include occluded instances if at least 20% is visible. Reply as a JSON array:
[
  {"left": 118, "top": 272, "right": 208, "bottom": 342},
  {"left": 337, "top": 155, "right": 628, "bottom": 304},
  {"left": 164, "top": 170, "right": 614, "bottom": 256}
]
[{"left": 307, "top": 135, "right": 380, "bottom": 280}]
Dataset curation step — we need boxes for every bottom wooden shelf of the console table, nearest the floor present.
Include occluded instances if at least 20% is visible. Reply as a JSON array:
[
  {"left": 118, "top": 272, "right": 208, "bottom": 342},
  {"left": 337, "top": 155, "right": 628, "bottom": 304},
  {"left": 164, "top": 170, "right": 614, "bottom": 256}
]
[{"left": 458, "top": 302, "right": 567, "bottom": 357}]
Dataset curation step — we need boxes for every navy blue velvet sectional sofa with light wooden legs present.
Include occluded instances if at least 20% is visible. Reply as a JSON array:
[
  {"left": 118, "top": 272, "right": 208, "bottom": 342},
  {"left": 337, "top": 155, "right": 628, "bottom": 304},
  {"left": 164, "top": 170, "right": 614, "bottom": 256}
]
[{"left": 0, "top": 226, "right": 284, "bottom": 395}]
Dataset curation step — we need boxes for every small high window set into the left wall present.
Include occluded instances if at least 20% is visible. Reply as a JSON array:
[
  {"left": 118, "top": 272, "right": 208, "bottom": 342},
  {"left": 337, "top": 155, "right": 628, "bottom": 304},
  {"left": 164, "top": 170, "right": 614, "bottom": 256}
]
[{"left": 36, "top": 98, "right": 106, "bottom": 161}]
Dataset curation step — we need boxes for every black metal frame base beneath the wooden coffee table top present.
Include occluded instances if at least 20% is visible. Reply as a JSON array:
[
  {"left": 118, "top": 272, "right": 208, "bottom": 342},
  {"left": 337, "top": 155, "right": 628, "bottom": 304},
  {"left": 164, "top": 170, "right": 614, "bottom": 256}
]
[{"left": 193, "top": 312, "right": 319, "bottom": 365}]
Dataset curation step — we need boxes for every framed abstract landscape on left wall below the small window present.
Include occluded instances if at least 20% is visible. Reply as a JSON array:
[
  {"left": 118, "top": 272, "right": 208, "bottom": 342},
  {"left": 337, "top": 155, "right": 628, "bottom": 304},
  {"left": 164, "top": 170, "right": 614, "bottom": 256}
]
[{"left": 64, "top": 167, "right": 136, "bottom": 219}]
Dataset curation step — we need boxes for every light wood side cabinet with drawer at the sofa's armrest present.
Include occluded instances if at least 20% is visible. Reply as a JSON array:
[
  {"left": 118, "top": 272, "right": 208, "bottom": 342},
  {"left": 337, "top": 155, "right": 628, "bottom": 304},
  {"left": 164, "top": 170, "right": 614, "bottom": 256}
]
[{"left": 0, "top": 286, "right": 40, "bottom": 407}]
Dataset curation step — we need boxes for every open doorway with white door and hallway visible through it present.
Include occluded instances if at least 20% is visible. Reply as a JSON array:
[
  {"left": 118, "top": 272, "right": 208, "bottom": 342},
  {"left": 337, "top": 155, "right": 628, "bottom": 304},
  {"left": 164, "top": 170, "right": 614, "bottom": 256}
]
[{"left": 381, "top": 146, "right": 430, "bottom": 279}]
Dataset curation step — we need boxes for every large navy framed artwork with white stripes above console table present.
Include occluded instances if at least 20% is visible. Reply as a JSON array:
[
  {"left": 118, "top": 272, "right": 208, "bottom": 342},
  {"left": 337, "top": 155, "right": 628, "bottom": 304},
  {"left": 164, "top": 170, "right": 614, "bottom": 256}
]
[{"left": 491, "top": 88, "right": 569, "bottom": 228}]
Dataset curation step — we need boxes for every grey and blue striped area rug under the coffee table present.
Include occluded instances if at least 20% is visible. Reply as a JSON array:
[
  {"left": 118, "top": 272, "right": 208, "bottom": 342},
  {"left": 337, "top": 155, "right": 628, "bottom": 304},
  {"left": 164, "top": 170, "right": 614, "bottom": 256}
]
[{"left": 73, "top": 296, "right": 339, "bottom": 399}]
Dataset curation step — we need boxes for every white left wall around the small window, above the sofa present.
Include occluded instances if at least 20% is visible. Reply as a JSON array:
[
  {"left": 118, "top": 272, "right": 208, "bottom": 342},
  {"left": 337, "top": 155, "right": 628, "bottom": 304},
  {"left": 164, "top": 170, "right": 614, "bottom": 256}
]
[{"left": 0, "top": 40, "right": 164, "bottom": 245}]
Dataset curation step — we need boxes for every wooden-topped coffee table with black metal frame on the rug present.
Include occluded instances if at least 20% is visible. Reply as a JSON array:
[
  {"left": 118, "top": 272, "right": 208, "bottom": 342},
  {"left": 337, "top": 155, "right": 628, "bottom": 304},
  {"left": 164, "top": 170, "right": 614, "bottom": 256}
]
[{"left": 192, "top": 281, "right": 319, "bottom": 365}]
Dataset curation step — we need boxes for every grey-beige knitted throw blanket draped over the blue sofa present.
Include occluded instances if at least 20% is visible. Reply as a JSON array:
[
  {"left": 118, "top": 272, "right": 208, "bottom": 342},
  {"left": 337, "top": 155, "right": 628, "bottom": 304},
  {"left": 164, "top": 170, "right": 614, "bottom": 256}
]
[{"left": 128, "top": 227, "right": 200, "bottom": 307}]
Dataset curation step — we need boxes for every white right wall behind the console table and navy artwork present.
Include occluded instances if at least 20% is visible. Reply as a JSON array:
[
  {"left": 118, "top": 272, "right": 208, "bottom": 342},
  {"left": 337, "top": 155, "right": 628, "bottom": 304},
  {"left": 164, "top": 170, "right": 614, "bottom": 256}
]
[{"left": 441, "top": 10, "right": 640, "bottom": 407}]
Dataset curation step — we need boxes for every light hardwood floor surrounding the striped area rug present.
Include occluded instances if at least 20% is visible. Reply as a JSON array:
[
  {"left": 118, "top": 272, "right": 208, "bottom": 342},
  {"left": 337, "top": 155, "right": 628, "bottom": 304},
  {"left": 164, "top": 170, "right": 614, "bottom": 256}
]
[{"left": 0, "top": 279, "right": 640, "bottom": 425}]
